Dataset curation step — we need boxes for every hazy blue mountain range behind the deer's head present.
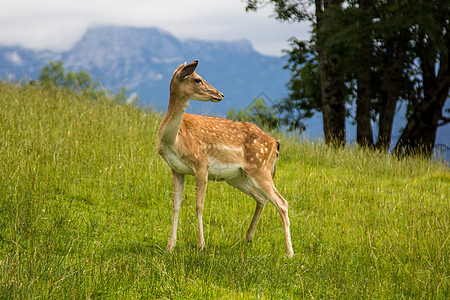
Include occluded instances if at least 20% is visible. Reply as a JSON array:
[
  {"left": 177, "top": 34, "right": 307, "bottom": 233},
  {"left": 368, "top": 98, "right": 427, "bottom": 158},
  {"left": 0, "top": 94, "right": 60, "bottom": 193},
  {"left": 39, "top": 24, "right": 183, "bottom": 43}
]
[{"left": 0, "top": 27, "right": 290, "bottom": 115}]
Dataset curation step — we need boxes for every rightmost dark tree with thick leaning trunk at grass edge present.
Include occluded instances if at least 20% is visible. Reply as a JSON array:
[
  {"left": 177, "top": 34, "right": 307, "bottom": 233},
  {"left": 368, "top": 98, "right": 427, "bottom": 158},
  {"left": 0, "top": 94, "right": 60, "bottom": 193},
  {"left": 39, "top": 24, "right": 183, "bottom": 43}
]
[{"left": 395, "top": 0, "right": 450, "bottom": 156}]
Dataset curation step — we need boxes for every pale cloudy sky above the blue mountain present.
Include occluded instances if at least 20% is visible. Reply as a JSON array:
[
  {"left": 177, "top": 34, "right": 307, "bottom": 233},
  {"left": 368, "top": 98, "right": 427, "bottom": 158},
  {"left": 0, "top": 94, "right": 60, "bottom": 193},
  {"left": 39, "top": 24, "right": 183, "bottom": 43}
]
[{"left": 0, "top": 0, "right": 310, "bottom": 56}]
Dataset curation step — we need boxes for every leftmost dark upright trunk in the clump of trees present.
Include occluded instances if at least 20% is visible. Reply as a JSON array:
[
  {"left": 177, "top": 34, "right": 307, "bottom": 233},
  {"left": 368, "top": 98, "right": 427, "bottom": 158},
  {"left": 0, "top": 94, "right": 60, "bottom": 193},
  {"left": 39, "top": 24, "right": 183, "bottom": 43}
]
[{"left": 315, "top": 0, "right": 345, "bottom": 145}]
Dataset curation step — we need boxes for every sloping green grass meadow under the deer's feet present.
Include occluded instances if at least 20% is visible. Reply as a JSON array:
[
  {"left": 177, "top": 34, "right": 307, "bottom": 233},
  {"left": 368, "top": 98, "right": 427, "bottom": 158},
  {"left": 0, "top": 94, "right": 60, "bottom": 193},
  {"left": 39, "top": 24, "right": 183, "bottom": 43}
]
[{"left": 0, "top": 83, "right": 450, "bottom": 299}]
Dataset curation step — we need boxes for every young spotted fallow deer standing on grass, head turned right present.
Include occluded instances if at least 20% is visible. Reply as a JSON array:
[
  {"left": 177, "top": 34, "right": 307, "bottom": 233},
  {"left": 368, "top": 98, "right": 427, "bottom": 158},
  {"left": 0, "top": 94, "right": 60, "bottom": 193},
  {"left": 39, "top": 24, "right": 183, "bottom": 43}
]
[{"left": 158, "top": 60, "right": 294, "bottom": 257}]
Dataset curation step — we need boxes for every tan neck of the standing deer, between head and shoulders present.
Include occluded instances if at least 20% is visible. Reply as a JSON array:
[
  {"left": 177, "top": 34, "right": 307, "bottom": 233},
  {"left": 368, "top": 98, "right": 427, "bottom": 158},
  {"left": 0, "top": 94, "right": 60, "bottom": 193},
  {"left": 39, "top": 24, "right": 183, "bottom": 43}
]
[{"left": 158, "top": 93, "right": 189, "bottom": 146}]
